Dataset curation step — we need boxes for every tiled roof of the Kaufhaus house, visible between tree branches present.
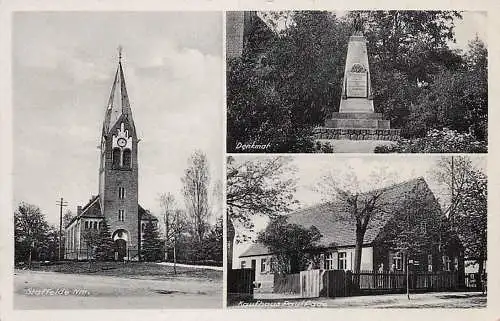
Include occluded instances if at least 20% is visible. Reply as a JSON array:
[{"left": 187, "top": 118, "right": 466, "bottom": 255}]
[{"left": 240, "top": 178, "right": 432, "bottom": 257}]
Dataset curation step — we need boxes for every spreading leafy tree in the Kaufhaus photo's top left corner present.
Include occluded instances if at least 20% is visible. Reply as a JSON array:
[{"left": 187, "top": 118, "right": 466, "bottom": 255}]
[{"left": 226, "top": 156, "right": 296, "bottom": 239}]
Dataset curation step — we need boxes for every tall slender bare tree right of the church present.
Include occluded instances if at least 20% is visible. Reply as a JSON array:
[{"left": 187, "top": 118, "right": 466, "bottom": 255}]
[{"left": 181, "top": 151, "right": 210, "bottom": 242}]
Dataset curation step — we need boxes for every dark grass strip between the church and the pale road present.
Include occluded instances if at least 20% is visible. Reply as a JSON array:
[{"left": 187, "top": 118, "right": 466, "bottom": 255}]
[{"left": 27, "top": 261, "right": 222, "bottom": 281}]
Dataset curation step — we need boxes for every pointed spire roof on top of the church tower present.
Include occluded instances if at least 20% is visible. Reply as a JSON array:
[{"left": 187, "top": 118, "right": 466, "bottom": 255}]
[{"left": 103, "top": 46, "right": 133, "bottom": 135}]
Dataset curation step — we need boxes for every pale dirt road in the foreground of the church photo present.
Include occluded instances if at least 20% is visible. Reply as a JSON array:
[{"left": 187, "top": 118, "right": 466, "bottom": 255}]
[{"left": 14, "top": 270, "right": 222, "bottom": 309}]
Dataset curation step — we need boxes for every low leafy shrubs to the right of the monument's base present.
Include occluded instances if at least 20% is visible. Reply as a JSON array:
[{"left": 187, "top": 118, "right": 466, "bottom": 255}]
[{"left": 375, "top": 128, "right": 488, "bottom": 153}]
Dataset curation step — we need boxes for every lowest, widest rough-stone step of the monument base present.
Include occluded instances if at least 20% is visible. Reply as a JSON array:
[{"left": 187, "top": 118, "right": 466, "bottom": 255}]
[{"left": 314, "top": 127, "right": 401, "bottom": 141}]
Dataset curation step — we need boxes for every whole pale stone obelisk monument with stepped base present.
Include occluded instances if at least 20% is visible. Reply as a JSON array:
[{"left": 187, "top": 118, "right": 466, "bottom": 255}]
[{"left": 315, "top": 15, "right": 400, "bottom": 141}]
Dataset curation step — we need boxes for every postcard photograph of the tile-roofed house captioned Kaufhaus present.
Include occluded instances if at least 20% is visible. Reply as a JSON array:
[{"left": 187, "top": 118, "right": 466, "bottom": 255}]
[{"left": 227, "top": 155, "right": 489, "bottom": 309}]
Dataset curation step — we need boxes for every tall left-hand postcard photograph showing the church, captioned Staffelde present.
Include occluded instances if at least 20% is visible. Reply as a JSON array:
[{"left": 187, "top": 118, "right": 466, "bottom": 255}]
[{"left": 12, "top": 11, "right": 224, "bottom": 310}]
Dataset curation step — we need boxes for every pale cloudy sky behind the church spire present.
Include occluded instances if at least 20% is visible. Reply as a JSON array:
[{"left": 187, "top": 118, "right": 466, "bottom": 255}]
[{"left": 12, "top": 12, "right": 223, "bottom": 224}]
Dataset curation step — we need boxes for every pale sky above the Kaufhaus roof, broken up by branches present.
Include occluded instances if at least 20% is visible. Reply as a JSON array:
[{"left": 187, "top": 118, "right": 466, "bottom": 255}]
[{"left": 233, "top": 154, "right": 487, "bottom": 266}]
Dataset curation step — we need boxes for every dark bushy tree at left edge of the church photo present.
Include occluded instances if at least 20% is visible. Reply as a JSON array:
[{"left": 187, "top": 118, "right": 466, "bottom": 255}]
[{"left": 14, "top": 202, "right": 49, "bottom": 267}]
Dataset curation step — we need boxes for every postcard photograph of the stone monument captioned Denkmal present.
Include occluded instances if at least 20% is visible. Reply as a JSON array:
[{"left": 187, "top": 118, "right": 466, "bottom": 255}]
[{"left": 226, "top": 10, "right": 488, "bottom": 153}]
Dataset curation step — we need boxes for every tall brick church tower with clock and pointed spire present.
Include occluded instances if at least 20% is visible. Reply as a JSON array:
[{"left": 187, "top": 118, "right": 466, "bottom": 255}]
[{"left": 99, "top": 50, "right": 140, "bottom": 257}]
